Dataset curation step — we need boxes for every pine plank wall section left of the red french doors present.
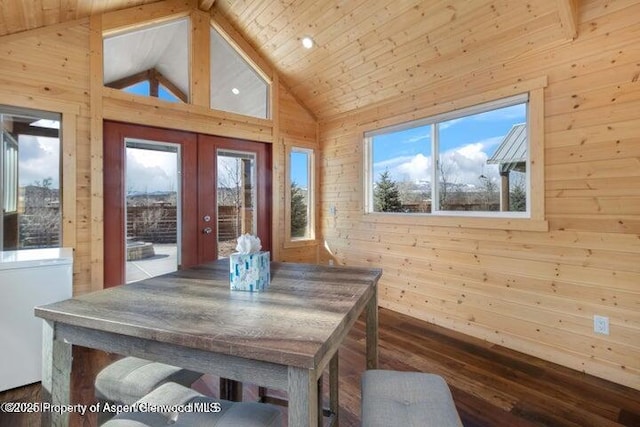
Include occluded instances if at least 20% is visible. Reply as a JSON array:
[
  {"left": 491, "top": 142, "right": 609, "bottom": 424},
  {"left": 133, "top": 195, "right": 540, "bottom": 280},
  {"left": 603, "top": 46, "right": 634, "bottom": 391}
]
[{"left": 0, "top": 19, "right": 91, "bottom": 293}]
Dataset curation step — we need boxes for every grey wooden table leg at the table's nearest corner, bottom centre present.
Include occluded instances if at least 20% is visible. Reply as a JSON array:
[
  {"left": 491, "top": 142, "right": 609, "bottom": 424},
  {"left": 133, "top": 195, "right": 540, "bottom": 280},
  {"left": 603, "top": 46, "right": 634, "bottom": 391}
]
[{"left": 287, "top": 366, "right": 321, "bottom": 427}]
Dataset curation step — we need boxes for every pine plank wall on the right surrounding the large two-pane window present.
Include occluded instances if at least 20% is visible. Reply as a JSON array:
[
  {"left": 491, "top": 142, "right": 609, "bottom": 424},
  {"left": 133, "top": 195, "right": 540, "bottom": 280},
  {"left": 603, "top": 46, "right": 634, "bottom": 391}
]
[{"left": 320, "top": 0, "right": 640, "bottom": 389}]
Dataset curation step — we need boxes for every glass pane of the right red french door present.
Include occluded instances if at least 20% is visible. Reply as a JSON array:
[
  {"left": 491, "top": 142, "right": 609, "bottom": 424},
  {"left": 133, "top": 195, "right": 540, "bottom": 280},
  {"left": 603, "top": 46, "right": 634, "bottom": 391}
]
[{"left": 216, "top": 150, "right": 257, "bottom": 258}]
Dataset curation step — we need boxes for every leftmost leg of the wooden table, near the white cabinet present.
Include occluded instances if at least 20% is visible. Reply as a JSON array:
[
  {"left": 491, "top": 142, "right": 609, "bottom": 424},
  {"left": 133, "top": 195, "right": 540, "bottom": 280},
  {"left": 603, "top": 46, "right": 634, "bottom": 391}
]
[{"left": 41, "top": 320, "right": 71, "bottom": 427}]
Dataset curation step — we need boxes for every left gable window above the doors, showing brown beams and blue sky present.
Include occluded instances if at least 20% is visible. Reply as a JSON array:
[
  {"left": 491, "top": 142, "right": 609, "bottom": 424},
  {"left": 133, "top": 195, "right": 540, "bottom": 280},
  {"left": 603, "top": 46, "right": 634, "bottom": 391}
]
[{"left": 104, "top": 18, "right": 189, "bottom": 102}]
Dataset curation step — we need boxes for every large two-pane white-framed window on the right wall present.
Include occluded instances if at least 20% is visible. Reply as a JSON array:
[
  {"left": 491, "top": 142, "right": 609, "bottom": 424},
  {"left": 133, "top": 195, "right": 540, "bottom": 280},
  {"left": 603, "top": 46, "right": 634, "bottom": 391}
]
[{"left": 365, "top": 94, "right": 531, "bottom": 218}]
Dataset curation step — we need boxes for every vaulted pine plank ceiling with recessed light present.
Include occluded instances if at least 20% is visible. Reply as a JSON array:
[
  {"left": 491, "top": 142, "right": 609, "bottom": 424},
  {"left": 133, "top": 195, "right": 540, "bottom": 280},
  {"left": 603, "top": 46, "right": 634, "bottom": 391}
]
[{"left": 0, "top": 0, "right": 577, "bottom": 118}]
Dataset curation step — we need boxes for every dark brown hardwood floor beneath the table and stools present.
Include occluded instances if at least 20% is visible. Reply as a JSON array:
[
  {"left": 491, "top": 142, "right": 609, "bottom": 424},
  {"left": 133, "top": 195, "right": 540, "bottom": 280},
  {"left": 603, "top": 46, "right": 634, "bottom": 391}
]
[{"left": 0, "top": 309, "right": 640, "bottom": 427}]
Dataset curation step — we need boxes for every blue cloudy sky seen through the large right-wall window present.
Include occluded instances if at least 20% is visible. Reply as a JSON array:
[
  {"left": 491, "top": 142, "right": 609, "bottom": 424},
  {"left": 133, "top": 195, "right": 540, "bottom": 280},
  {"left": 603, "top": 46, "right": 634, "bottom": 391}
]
[{"left": 373, "top": 104, "right": 526, "bottom": 185}]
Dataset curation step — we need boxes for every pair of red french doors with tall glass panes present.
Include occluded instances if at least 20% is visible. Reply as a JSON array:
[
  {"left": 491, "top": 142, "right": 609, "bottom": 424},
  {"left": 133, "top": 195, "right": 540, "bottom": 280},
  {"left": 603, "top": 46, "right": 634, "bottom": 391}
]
[{"left": 104, "top": 121, "right": 271, "bottom": 287}]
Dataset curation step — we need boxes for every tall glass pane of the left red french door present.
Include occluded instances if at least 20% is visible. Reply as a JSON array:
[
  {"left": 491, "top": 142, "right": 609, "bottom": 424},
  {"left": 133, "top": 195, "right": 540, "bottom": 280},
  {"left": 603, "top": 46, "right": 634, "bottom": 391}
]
[{"left": 125, "top": 140, "right": 181, "bottom": 283}]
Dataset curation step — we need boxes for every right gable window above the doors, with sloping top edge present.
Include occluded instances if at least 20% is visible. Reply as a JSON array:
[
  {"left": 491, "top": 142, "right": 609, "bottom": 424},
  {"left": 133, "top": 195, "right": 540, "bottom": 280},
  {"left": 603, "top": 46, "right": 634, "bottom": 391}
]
[{"left": 211, "top": 28, "right": 269, "bottom": 119}]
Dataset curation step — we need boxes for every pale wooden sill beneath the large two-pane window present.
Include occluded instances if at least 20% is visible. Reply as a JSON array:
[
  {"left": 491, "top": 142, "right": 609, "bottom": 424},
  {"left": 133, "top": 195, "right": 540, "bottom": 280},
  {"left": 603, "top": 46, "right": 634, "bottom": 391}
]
[{"left": 362, "top": 213, "right": 549, "bottom": 231}]
